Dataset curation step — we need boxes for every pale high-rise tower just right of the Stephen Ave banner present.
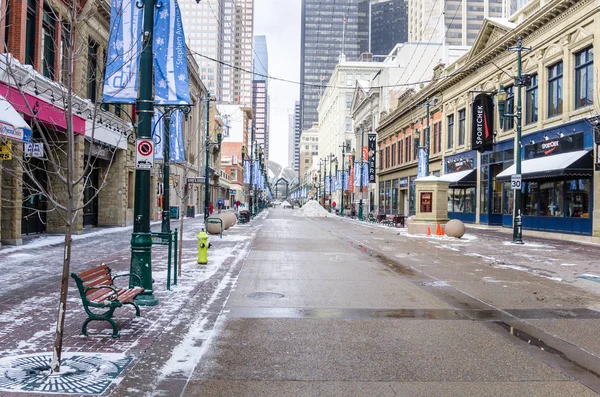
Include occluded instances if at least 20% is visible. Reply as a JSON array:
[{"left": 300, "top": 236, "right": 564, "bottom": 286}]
[{"left": 179, "top": 0, "right": 254, "bottom": 106}]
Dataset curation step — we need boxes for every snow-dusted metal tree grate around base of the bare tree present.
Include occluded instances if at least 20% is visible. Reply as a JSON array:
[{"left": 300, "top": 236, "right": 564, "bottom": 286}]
[{"left": 0, "top": 353, "right": 132, "bottom": 395}]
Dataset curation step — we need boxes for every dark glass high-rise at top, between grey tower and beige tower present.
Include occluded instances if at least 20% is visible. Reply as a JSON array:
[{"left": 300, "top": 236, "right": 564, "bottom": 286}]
[{"left": 358, "top": 0, "right": 408, "bottom": 57}]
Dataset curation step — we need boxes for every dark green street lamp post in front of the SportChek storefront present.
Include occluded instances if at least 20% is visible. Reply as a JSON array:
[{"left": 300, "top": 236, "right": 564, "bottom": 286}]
[{"left": 496, "top": 36, "right": 531, "bottom": 244}]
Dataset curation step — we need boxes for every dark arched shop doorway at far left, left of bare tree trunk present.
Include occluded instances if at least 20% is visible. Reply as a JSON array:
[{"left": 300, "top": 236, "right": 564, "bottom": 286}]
[{"left": 21, "top": 158, "right": 48, "bottom": 234}]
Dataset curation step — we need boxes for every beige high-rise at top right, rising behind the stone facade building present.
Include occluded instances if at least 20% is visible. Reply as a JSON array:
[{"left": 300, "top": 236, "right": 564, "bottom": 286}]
[{"left": 408, "top": 0, "right": 506, "bottom": 46}]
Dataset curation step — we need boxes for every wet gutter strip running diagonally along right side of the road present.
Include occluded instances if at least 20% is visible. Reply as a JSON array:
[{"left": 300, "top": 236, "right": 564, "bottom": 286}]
[{"left": 328, "top": 218, "right": 600, "bottom": 394}]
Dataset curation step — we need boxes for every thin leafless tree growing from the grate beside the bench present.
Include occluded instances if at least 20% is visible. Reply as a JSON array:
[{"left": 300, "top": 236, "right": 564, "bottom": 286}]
[{"left": 0, "top": 0, "right": 135, "bottom": 372}]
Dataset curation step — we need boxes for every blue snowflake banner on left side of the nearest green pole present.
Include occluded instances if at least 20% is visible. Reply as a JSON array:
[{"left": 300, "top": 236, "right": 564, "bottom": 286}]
[{"left": 102, "top": 0, "right": 142, "bottom": 103}]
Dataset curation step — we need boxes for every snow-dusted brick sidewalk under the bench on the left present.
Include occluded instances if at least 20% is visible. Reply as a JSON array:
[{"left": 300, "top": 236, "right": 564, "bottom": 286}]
[{"left": 0, "top": 212, "right": 260, "bottom": 396}]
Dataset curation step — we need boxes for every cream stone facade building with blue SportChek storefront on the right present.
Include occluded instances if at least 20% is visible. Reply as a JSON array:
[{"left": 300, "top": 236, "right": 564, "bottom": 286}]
[{"left": 378, "top": 0, "right": 600, "bottom": 238}]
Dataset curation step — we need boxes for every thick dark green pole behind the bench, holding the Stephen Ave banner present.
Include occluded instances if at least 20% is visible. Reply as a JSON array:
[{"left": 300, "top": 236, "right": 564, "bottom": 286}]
[{"left": 129, "top": 0, "right": 158, "bottom": 306}]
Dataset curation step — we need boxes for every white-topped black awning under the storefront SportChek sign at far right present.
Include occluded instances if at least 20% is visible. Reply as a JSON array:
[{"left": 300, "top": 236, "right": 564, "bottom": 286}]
[{"left": 496, "top": 150, "right": 594, "bottom": 181}]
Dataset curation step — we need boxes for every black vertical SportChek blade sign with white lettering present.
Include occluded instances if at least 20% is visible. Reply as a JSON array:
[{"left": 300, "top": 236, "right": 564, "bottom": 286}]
[{"left": 471, "top": 94, "right": 494, "bottom": 153}]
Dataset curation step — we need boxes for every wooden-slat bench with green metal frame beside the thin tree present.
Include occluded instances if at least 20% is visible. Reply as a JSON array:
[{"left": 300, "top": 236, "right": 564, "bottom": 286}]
[{"left": 71, "top": 263, "right": 144, "bottom": 338}]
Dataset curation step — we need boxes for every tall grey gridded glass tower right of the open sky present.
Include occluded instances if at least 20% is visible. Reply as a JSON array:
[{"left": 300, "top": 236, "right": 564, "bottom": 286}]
[{"left": 296, "top": 0, "right": 369, "bottom": 131}]
